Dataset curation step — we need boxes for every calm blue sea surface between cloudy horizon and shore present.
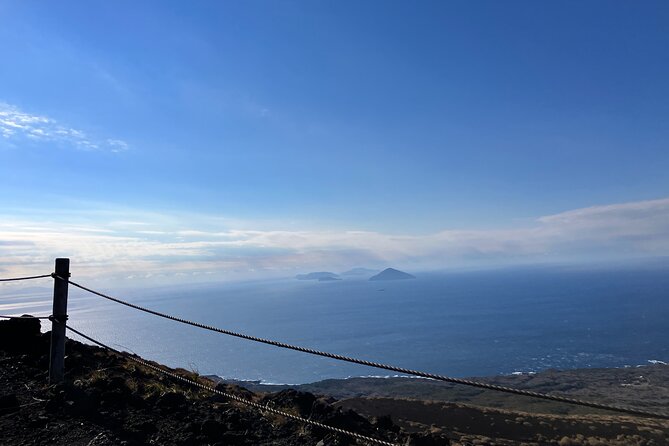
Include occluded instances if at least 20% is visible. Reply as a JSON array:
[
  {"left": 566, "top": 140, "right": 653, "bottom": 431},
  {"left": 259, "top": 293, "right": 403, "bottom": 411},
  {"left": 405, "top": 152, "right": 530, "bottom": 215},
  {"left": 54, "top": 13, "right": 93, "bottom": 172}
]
[{"left": 0, "top": 268, "right": 669, "bottom": 383}]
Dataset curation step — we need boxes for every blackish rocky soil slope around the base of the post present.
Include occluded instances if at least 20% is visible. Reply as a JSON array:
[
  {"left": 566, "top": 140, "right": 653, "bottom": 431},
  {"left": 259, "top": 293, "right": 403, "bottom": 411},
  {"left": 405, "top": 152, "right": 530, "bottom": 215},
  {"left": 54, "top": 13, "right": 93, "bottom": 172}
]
[{"left": 0, "top": 319, "right": 428, "bottom": 446}]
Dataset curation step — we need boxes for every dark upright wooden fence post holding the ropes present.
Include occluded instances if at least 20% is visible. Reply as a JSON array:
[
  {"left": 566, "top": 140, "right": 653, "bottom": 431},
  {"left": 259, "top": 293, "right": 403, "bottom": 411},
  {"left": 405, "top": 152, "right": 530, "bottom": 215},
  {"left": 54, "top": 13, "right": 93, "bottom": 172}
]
[{"left": 49, "top": 259, "right": 70, "bottom": 384}]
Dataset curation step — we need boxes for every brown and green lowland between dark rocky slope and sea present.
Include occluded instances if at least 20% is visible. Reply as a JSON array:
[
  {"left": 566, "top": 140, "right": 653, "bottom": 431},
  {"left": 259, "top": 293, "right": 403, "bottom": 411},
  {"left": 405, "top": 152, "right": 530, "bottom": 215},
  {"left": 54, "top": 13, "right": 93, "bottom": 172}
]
[{"left": 219, "top": 365, "right": 669, "bottom": 446}]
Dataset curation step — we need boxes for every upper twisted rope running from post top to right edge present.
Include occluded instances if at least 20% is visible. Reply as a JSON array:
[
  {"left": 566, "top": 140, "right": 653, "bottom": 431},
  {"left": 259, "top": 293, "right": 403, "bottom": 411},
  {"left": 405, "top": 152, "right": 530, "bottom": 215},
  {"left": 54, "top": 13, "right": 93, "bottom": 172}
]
[{"left": 53, "top": 274, "right": 669, "bottom": 419}]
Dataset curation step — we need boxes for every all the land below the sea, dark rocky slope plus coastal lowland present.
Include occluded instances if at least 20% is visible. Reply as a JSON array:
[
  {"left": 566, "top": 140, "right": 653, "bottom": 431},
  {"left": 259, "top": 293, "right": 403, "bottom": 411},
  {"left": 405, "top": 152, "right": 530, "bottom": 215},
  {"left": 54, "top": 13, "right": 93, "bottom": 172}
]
[{"left": 0, "top": 320, "right": 669, "bottom": 446}]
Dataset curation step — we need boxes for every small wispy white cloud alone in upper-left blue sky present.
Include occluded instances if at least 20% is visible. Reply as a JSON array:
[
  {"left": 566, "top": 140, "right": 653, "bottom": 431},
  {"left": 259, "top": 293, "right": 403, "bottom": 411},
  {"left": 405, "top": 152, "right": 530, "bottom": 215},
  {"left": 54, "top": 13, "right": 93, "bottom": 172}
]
[{"left": 0, "top": 102, "right": 129, "bottom": 152}]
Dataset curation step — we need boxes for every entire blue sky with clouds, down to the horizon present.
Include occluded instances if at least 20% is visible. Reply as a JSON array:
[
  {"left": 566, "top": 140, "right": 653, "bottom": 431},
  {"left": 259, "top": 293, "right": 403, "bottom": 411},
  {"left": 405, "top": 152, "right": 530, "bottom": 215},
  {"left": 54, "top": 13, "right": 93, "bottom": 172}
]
[{"left": 0, "top": 0, "right": 669, "bottom": 284}]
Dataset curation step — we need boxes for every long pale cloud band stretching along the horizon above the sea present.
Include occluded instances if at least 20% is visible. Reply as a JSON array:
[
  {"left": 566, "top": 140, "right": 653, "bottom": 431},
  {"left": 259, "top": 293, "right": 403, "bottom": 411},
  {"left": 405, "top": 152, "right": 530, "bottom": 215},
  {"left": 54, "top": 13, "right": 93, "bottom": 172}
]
[{"left": 0, "top": 198, "right": 669, "bottom": 286}]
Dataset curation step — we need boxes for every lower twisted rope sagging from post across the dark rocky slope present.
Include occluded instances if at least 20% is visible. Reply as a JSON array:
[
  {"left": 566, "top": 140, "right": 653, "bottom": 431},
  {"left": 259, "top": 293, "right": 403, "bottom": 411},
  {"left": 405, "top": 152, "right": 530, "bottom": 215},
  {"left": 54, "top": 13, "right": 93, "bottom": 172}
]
[{"left": 61, "top": 321, "right": 398, "bottom": 446}]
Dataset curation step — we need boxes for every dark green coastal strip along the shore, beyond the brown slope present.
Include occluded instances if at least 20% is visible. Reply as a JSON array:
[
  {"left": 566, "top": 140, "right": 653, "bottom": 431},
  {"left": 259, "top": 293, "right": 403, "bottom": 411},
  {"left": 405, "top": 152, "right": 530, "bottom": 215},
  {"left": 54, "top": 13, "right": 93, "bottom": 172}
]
[{"left": 207, "top": 360, "right": 669, "bottom": 415}]
